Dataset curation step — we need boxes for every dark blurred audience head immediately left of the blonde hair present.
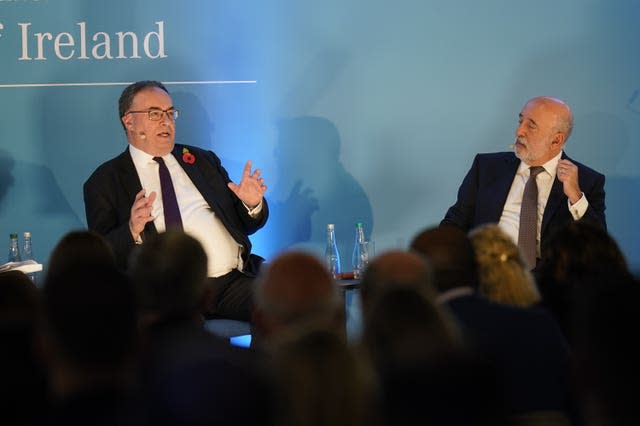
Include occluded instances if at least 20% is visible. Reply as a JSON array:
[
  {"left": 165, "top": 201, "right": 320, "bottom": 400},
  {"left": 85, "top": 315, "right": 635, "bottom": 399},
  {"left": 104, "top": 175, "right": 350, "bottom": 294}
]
[{"left": 410, "top": 226, "right": 478, "bottom": 293}]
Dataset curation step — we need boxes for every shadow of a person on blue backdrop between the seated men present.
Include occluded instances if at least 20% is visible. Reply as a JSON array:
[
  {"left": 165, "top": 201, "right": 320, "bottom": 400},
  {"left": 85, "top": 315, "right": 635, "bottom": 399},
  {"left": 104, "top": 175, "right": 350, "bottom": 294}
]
[{"left": 265, "top": 116, "right": 373, "bottom": 260}]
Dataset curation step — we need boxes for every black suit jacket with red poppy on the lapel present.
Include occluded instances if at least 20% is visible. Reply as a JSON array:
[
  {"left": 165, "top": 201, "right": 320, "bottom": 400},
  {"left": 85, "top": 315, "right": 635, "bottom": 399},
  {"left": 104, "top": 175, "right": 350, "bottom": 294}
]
[{"left": 84, "top": 145, "right": 269, "bottom": 270}]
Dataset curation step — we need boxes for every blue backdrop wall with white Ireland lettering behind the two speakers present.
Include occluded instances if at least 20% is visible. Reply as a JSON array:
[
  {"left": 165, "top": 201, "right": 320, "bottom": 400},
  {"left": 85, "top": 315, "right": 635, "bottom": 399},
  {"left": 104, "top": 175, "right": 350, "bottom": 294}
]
[{"left": 0, "top": 0, "right": 640, "bottom": 270}]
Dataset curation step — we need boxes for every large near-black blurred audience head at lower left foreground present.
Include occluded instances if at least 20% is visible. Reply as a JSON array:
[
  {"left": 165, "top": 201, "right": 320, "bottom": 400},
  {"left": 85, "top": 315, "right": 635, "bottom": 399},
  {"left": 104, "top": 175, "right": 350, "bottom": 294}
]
[{"left": 41, "top": 265, "right": 137, "bottom": 393}]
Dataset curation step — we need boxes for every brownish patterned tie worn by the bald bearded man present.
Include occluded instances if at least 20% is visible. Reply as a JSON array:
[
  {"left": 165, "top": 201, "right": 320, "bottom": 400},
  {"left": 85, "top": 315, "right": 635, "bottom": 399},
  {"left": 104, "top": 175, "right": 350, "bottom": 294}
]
[{"left": 518, "top": 166, "right": 544, "bottom": 270}]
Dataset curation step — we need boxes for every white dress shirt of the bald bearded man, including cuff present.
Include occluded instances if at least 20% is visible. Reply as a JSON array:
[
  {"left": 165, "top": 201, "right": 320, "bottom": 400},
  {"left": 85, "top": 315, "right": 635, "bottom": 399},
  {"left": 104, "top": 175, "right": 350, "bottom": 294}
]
[{"left": 498, "top": 151, "right": 589, "bottom": 257}]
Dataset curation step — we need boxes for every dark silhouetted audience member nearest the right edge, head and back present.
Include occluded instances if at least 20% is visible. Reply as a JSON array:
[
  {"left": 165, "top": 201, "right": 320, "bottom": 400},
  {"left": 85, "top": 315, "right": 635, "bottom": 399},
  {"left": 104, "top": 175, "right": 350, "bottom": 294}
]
[{"left": 538, "top": 221, "right": 640, "bottom": 425}]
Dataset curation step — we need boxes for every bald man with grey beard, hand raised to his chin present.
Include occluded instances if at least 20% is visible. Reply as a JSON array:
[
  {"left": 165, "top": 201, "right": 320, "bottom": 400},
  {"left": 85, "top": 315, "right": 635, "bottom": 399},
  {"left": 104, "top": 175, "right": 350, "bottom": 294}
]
[{"left": 441, "top": 96, "right": 606, "bottom": 270}]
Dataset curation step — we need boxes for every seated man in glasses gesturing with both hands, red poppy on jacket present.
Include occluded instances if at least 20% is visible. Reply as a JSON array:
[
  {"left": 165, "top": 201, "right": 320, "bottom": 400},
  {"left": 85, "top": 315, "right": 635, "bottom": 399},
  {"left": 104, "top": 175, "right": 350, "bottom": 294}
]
[{"left": 84, "top": 81, "right": 268, "bottom": 321}]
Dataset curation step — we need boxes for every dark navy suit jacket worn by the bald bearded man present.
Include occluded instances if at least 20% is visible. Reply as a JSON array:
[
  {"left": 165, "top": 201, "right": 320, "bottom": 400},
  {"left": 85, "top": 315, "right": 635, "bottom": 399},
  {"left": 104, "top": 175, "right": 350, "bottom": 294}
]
[{"left": 440, "top": 152, "right": 607, "bottom": 255}]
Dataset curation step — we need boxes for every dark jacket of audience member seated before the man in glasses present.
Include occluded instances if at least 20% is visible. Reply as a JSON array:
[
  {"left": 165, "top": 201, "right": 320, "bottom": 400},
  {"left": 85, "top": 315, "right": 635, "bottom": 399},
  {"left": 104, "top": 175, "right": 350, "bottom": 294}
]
[{"left": 140, "top": 318, "right": 272, "bottom": 426}]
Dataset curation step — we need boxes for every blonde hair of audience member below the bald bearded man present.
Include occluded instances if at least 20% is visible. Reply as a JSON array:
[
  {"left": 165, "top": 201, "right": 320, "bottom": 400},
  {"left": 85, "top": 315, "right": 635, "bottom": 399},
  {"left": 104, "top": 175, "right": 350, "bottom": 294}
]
[{"left": 469, "top": 224, "right": 540, "bottom": 307}]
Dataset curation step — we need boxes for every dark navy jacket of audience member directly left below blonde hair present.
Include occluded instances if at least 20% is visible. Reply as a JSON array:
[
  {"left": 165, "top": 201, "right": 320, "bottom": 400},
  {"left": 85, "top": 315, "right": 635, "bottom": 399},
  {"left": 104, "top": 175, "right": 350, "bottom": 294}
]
[{"left": 445, "top": 295, "right": 570, "bottom": 414}]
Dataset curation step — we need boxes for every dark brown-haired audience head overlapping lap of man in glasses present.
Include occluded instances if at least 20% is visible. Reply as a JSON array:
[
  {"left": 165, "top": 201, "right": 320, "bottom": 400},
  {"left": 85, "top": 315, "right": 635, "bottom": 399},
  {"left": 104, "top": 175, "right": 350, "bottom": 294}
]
[{"left": 129, "top": 230, "right": 210, "bottom": 320}]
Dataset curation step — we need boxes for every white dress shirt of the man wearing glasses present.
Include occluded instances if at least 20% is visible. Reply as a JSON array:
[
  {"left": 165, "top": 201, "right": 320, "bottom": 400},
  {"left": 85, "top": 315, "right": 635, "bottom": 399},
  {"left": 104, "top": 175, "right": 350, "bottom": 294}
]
[{"left": 129, "top": 145, "right": 248, "bottom": 277}]
